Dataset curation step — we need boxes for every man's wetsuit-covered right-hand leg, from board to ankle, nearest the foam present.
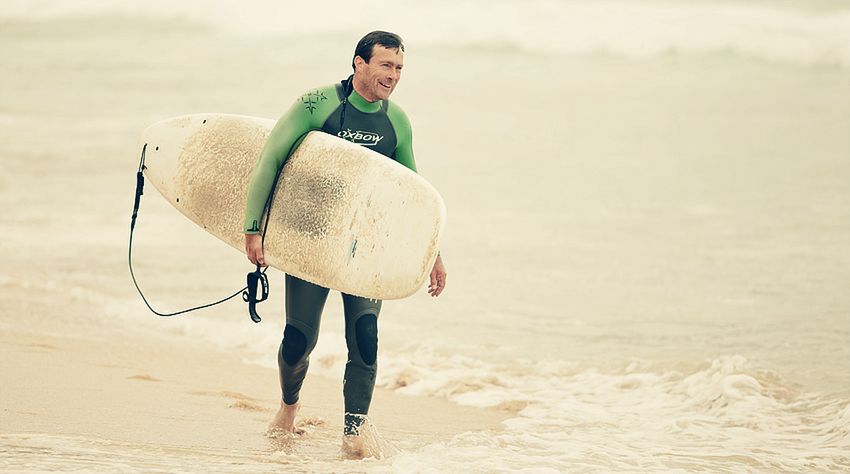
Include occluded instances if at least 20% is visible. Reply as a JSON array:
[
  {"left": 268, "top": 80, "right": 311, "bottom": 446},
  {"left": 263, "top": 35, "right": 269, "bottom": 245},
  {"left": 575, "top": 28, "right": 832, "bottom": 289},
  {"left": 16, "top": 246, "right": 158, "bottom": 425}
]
[{"left": 342, "top": 294, "right": 381, "bottom": 435}]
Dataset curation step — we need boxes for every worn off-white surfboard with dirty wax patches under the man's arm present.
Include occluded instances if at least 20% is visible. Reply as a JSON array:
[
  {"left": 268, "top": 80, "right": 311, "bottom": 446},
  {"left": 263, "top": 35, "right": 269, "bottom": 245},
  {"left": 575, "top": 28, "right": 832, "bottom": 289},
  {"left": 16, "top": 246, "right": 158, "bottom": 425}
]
[{"left": 142, "top": 114, "right": 446, "bottom": 300}]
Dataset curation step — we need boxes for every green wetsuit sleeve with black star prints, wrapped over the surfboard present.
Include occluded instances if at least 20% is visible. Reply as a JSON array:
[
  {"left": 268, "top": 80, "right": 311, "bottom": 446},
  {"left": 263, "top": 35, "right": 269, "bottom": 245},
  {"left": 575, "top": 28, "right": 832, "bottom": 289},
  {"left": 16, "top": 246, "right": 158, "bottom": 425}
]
[{"left": 242, "top": 85, "right": 340, "bottom": 234}]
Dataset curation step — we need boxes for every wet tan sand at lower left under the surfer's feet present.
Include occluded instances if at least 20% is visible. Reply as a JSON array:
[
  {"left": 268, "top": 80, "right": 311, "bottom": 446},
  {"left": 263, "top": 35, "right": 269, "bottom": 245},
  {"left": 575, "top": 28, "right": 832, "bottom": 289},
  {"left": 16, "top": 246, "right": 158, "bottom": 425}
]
[{"left": 0, "top": 308, "right": 509, "bottom": 472}]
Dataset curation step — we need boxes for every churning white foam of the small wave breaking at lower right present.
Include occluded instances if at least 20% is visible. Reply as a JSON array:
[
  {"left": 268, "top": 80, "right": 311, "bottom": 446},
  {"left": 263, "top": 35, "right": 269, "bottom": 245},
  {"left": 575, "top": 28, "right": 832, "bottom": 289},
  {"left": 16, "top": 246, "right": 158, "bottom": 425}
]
[{"left": 386, "top": 355, "right": 850, "bottom": 472}]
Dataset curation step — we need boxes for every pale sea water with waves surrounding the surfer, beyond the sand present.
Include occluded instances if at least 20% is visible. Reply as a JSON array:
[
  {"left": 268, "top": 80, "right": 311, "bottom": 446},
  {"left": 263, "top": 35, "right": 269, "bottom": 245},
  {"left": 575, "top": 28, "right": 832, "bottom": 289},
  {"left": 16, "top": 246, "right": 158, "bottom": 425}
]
[{"left": 0, "top": 0, "right": 850, "bottom": 472}]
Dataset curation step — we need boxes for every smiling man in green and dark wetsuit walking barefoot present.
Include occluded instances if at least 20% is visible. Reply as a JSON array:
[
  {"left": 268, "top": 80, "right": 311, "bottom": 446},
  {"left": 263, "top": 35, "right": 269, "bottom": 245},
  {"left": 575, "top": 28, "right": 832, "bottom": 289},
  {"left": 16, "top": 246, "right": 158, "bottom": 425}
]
[{"left": 244, "top": 31, "right": 446, "bottom": 455}]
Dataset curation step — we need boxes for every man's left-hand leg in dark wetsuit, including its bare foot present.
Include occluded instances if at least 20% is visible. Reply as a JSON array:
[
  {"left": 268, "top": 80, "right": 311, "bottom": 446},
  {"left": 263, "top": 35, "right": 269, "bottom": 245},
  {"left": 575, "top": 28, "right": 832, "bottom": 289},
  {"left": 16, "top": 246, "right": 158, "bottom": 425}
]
[{"left": 269, "top": 275, "right": 328, "bottom": 432}]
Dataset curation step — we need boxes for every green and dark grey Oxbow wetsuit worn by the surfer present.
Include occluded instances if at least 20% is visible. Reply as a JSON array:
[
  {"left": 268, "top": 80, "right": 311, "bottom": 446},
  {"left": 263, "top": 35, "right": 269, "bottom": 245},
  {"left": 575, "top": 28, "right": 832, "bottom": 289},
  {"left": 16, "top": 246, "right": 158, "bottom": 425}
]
[{"left": 243, "top": 78, "right": 416, "bottom": 434}]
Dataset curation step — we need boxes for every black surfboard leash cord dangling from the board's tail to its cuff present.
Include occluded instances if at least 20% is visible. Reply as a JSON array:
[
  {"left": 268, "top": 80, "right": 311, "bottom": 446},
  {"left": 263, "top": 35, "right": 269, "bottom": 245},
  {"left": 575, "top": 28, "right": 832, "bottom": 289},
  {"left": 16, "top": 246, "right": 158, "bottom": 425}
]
[{"left": 127, "top": 143, "right": 269, "bottom": 323}]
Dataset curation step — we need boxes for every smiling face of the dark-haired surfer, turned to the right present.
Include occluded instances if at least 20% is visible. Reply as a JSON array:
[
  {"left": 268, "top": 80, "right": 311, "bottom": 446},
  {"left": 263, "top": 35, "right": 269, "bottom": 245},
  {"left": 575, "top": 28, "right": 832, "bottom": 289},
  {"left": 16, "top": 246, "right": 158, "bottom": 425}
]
[{"left": 354, "top": 44, "right": 404, "bottom": 102}]
